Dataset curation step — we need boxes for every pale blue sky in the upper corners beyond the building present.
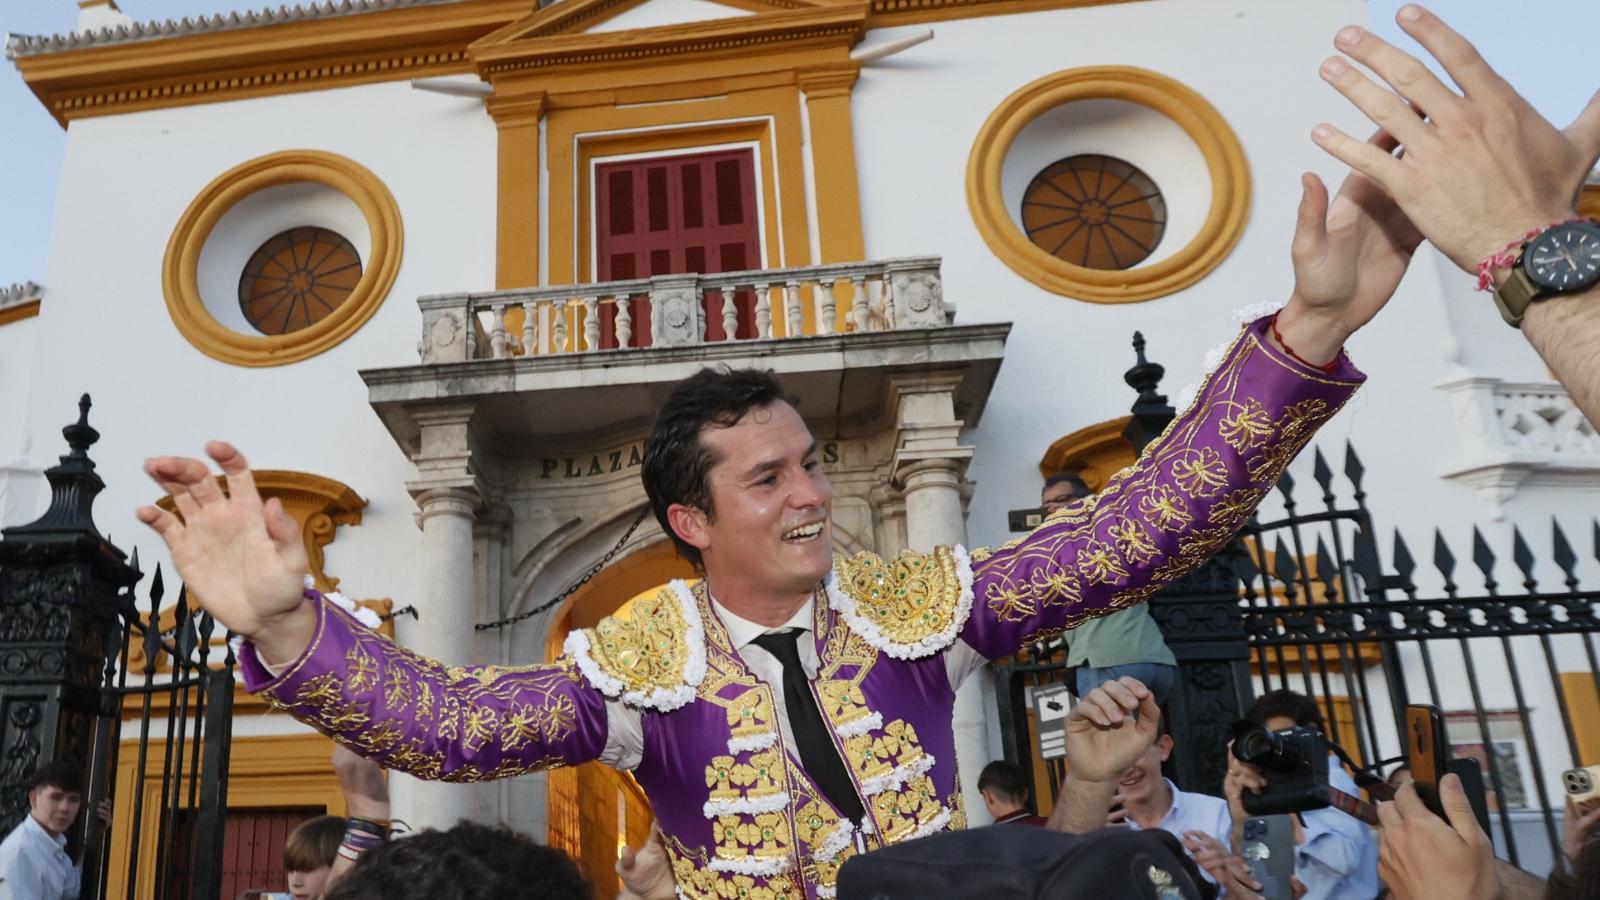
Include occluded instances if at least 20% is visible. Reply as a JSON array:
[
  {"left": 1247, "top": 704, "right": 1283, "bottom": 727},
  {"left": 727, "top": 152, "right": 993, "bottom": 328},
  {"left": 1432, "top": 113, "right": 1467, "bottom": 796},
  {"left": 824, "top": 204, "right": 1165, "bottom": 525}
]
[{"left": 0, "top": 0, "right": 1600, "bottom": 288}]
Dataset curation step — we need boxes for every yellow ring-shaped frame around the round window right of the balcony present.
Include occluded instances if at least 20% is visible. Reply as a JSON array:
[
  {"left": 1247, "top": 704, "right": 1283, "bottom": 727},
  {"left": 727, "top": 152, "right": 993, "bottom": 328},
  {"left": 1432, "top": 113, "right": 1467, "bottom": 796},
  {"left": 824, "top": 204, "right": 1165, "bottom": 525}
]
[{"left": 966, "top": 66, "right": 1250, "bottom": 303}]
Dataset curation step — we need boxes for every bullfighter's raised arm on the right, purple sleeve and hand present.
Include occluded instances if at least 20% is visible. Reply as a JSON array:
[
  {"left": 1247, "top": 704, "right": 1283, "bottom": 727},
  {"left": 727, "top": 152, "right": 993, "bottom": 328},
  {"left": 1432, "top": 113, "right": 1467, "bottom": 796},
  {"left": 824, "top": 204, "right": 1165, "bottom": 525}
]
[{"left": 962, "top": 156, "right": 1421, "bottom": 658}]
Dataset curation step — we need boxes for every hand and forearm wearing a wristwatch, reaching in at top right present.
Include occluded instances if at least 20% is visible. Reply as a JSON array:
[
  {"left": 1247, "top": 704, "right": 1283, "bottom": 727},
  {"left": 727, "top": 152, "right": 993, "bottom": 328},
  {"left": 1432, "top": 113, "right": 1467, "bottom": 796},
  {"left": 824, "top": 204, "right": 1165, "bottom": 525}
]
[{"left": 1312, "top": 5, "right": 1600, "bottom": 421}]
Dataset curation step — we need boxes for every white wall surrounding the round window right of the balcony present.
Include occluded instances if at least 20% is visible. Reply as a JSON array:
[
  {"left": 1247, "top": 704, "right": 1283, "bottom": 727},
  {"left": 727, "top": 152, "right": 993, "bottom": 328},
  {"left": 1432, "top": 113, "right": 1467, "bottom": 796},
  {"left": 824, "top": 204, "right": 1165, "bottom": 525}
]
[{"left": 853, "top": 0, "right": 1600, "bottom": 560}]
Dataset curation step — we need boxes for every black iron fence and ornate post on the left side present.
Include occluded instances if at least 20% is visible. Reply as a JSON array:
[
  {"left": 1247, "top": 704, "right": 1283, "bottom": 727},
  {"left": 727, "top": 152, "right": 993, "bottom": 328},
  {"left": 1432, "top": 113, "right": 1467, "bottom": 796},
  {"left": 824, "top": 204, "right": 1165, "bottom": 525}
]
[{"left": 0, "top": 396, "right": 235, "bottom": 900}]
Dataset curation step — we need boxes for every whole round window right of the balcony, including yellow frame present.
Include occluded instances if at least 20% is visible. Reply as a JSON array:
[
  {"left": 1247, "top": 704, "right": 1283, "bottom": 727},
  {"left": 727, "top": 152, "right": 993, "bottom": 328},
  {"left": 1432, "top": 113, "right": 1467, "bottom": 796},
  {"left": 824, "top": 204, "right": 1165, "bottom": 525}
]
[{"left": 966, "top": 66, "right": 1250, "bottom": 303}]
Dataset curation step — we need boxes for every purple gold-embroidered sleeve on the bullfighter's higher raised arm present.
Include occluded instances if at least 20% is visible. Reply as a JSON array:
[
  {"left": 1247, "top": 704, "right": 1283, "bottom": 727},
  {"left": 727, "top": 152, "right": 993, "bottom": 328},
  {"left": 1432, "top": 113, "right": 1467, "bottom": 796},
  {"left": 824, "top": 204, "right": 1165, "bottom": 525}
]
[{"left": 962, "top": 319, "right": 1366, "bottom": 658}]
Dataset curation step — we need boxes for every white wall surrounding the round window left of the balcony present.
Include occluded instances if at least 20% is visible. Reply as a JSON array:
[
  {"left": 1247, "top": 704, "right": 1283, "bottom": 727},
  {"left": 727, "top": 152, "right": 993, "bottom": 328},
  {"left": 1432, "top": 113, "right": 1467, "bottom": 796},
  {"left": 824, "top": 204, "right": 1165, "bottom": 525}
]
[{"left": 23, "top": 75, "right": 494, "bottom": 626}]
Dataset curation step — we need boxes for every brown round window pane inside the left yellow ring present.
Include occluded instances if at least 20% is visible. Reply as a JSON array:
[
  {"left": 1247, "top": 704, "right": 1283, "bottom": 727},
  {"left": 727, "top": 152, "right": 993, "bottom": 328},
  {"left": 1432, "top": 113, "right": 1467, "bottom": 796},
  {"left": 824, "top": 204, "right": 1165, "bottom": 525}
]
[{"left": 238, "top": 227, "right": 362, "bottom": 335}]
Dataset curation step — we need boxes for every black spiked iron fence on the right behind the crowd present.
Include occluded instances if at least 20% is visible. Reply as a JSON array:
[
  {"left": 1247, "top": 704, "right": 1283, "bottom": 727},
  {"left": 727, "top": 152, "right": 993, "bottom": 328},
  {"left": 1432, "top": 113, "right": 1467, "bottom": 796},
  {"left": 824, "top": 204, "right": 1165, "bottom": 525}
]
[{"left": 998, "top": 447, "right": 1600, "bottom": 871}]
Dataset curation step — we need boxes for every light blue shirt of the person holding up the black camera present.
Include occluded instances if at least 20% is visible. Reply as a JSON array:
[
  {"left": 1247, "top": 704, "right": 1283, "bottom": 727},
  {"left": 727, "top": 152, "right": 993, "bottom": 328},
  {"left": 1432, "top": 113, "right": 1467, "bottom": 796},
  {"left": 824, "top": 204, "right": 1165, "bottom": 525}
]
[{"left": 1294, "top": 756, "right": 1378, "bottom": 900}]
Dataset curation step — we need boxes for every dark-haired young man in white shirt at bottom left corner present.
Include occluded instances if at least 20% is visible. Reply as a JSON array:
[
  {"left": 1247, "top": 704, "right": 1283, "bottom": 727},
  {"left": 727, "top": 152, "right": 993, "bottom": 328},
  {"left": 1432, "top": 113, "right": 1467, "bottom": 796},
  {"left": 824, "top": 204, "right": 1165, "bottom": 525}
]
[{"left": 0, "top": 762, "right": 83, "bottom": 900}]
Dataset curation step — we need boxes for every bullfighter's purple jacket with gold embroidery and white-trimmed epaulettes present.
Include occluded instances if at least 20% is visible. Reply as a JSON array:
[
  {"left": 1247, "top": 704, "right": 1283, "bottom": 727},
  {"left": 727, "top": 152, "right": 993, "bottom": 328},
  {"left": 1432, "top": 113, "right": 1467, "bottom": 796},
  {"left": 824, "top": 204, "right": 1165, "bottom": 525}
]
[{"left": 242, "top": 315, "right": 1363, "bottom": 900}]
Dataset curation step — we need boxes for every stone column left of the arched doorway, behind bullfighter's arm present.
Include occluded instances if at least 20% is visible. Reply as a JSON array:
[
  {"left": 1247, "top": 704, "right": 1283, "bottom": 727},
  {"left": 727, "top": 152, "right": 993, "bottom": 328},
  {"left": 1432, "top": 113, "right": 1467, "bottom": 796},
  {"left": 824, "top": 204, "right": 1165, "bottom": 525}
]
[{"left": 390, "top": 405, "right": 491, "bottom": 830}]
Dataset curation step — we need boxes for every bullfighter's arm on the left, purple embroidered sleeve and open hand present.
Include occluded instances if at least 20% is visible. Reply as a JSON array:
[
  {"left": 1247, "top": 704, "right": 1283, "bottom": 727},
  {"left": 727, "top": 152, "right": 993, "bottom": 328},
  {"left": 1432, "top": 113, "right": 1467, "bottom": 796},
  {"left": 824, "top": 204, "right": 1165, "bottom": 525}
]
[{"left": 139, "top": 440, "right": 606, "bottom": 781}]
